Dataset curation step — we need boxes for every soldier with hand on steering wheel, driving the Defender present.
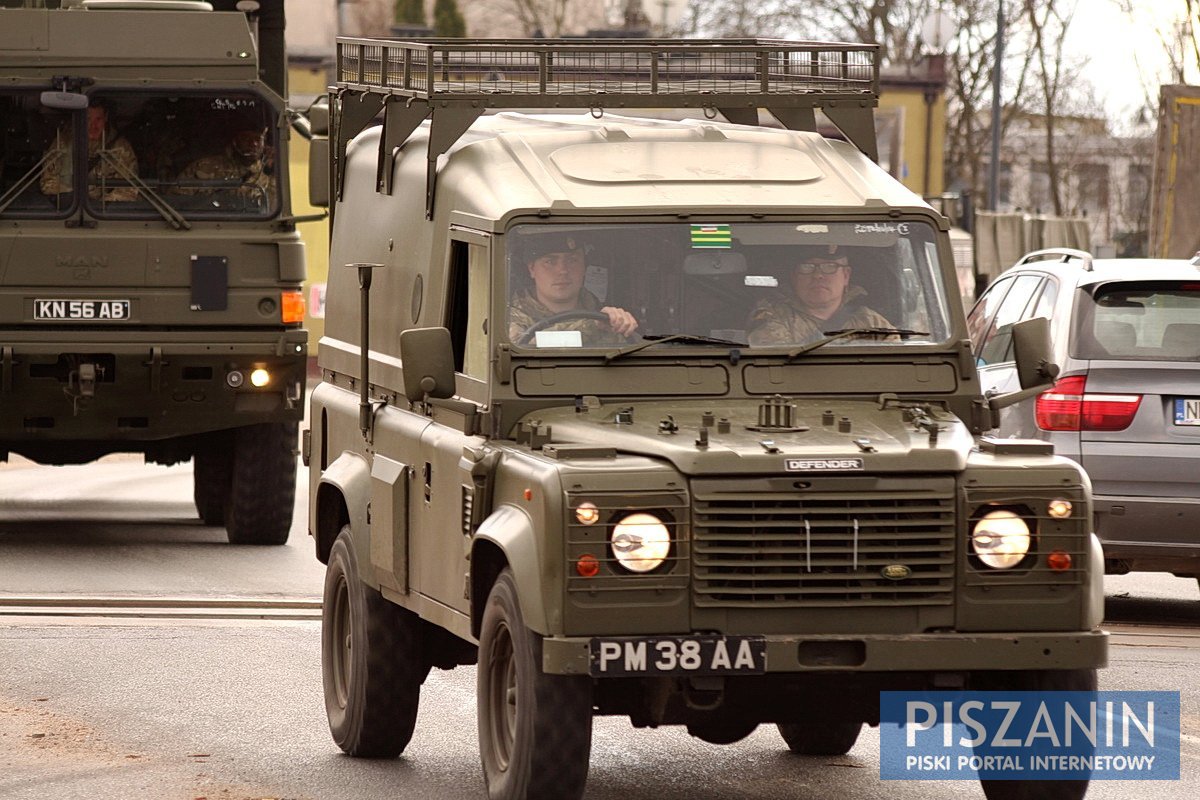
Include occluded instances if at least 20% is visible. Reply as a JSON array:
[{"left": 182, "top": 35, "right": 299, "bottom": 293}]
[{"left": 509, "top": 233, "right": 637, "bottom": 347}]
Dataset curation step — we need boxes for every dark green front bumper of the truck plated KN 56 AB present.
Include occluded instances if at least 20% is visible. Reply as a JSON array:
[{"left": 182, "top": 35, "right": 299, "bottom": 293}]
[{"left": 0, "top": 329, "right": 307, "bottom": 450}]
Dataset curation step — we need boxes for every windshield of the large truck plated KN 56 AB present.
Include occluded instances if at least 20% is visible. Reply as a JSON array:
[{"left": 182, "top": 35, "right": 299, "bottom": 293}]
[{"left": 0, "top": 90, "right": 280, "bottom": 219}]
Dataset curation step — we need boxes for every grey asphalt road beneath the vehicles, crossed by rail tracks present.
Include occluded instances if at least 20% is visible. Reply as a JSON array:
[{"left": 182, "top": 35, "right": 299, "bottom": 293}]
[{"left": 0, "top": 458, "right": 1200, "bottom": 800}]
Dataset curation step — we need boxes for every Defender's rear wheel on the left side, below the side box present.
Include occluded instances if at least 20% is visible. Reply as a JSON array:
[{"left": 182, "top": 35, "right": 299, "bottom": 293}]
[{"left": 320, "top": 525, "right": 428, "bottom": 758}]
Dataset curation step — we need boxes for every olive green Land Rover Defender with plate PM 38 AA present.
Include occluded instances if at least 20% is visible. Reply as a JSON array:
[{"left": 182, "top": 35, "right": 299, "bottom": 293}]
[{"left": 302, "top": 38, "right": 1106, "bottom": 800}]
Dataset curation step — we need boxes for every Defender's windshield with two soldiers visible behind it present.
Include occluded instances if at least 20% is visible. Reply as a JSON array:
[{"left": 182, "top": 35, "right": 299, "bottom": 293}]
[{"left": 505, "top": 219, "right": 949, "bottom": 349}]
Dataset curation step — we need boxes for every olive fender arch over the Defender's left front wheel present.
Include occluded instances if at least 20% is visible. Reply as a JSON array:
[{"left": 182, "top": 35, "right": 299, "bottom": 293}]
[{"left": 470, "top": 505, "right": 563, "bottom": 634}]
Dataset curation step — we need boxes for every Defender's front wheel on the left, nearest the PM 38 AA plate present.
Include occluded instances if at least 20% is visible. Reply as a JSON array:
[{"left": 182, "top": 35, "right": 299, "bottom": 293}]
[{"left": 476, "top": 570, "right": 592, "bottom": 800}]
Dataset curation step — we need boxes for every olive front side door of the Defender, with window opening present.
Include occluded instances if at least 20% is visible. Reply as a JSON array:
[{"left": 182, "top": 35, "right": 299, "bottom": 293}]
[{"left": 413, "top": 230, "right": 491, "bottom": 613}]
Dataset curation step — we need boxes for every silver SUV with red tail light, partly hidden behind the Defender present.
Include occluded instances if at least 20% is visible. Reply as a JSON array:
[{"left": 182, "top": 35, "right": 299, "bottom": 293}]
[{"left": 967, "top": 249, "right": 1200, "bottom": 578}]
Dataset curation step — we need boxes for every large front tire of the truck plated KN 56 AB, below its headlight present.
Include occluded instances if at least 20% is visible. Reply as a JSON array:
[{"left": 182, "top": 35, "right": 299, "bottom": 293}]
[{"left": 226, "top": 422, "right": 296, "bottom": 545}]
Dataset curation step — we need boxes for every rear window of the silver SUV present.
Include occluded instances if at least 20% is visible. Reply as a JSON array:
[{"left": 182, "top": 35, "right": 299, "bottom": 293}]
[{"left": 1072, "top": 281, "right": 1200, "bottom": 361}]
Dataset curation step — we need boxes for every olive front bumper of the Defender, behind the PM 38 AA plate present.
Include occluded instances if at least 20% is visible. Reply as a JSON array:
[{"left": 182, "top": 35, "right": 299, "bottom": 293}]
[{"left": 542, "top": 630, "right": 1109, "bottom": 675}]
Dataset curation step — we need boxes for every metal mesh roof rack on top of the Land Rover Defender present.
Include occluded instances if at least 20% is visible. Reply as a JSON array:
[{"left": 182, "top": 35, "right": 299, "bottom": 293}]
[{"left": 332, "top": 37, "right": 880, "bottom": 217}]
